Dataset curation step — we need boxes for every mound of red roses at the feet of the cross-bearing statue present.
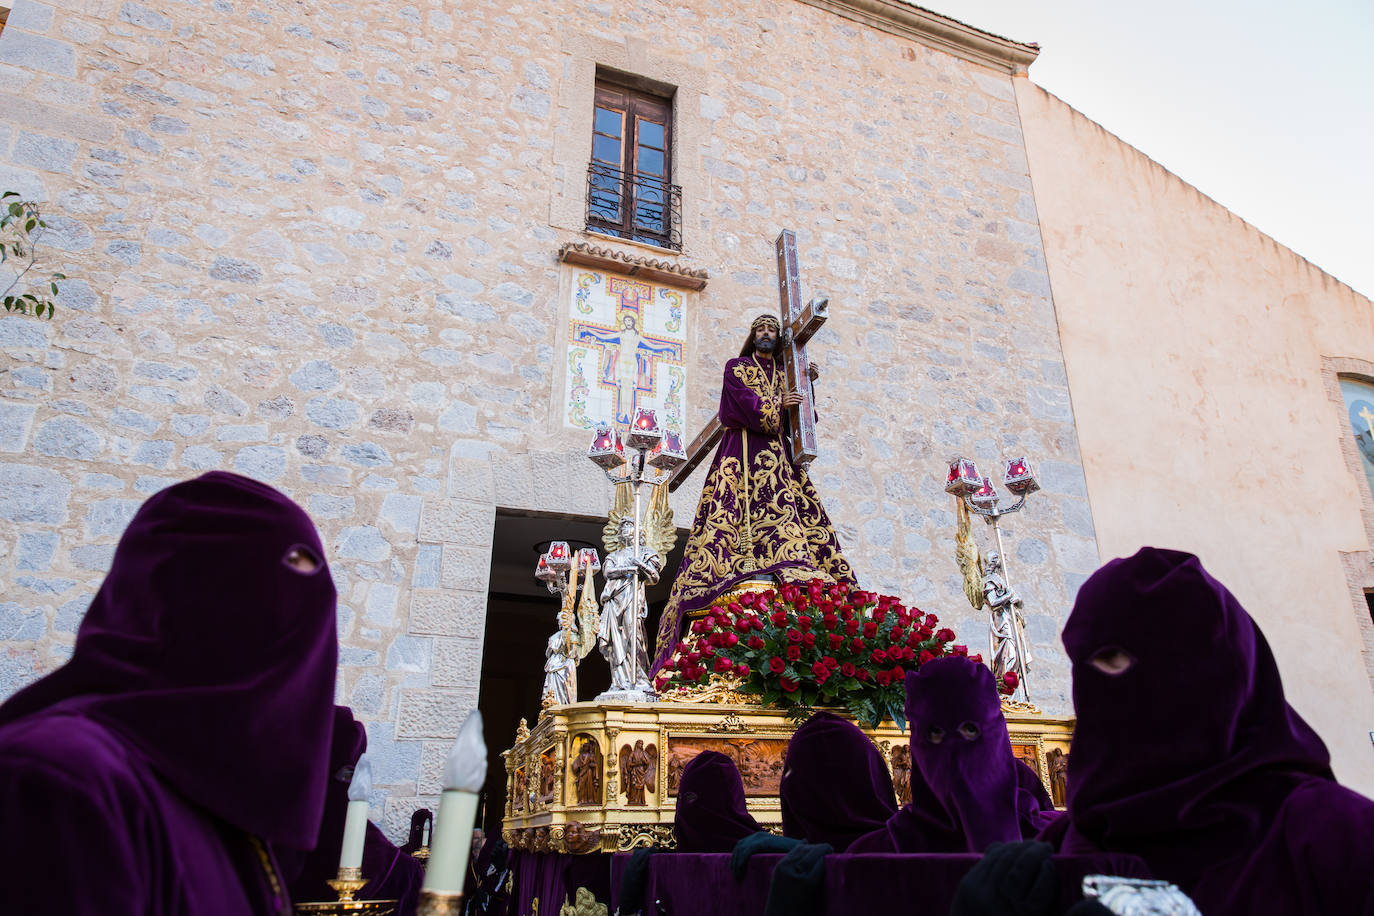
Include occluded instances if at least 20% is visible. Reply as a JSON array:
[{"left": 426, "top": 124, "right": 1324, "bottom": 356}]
[{"left": 654, "top": 580, "right": 982, "bottom": 728}]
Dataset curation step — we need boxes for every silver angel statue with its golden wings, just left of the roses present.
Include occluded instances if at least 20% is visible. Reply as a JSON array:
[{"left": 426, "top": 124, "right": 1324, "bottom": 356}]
[{"left": 596, "top": 485, "right": 676, "bottom": 699}]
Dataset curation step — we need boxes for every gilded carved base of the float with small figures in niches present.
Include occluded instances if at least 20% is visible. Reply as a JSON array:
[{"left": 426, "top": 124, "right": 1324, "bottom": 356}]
[{"left": 502, "top": 697, "right": 1073, "bottom": 854}]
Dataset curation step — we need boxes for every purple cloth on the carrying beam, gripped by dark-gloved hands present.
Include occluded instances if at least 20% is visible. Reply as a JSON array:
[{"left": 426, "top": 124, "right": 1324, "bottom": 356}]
[{"left": 607, "top": 853, "right": 1154, "bottom": 916}]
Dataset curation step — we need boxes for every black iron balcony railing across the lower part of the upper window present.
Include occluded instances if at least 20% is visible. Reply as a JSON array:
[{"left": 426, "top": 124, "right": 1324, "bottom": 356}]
[{"left": 587, "top": 162, "right": 683, "bottom": 251}]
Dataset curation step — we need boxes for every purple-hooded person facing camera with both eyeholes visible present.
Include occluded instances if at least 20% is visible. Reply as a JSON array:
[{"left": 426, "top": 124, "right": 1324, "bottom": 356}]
[{"left": 853, "top": 656, "right": 1022, "bottom": 853}]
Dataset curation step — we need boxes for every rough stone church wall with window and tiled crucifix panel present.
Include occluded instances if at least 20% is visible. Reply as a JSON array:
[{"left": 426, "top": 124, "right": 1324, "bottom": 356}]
[{"left": 0, "top": 0, "right": 1098, "bottom": 834}]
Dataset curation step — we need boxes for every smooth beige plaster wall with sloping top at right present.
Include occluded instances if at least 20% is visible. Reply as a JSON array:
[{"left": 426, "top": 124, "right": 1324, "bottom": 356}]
[{"left": 1015, "top": 78, "right": 1374, "bottom": 794}]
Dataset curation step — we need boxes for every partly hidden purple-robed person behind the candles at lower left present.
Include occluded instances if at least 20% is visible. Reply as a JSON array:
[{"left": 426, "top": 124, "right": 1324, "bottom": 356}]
[{"left": 279, "top": 706, "right": 425, "bottom": 916}]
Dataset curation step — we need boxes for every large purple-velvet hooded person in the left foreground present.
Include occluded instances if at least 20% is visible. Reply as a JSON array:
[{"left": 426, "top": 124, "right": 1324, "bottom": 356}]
[{"left": 0, "top": 472, "right": 338, "bottom": 916}]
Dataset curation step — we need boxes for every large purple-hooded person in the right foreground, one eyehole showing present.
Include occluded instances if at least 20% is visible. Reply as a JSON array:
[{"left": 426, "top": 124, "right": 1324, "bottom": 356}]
[{"left": 1048, "top": 548, "right": 1374, "bottom": 916}]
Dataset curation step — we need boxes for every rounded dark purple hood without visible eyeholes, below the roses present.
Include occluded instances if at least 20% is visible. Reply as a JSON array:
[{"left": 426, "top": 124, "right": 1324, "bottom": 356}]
[{"left": 778, "top": 713, "right": 897, "bottom": 853}]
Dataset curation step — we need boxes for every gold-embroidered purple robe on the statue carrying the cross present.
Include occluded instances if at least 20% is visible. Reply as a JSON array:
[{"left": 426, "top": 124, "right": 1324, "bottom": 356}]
[{"left": 655, "top": 353, "right": 855, "bottom": 669}]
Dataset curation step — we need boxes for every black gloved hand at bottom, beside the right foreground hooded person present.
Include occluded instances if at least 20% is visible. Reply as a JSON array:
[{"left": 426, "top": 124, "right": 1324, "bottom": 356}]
[{"left": 949, "top": 840, "right": 1058, "bottom": 916}]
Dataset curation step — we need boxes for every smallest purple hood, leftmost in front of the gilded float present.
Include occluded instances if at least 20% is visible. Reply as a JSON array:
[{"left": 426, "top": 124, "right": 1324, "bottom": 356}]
[{"left": 673, "top": 751, "right": 763, "bottom": 853}]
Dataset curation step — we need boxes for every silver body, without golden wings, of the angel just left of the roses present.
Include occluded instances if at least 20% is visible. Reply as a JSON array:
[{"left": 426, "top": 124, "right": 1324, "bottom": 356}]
[{"left": 596, "top": 518, "right": 664, "bottom": 692}]
